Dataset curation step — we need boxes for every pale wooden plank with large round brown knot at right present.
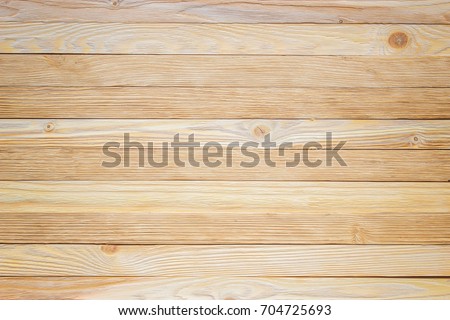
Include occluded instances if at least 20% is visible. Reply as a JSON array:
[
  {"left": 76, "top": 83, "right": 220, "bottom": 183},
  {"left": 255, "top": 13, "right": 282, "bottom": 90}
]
[{"left": 0, "top": 22, "right": 450, "bottom": 56}]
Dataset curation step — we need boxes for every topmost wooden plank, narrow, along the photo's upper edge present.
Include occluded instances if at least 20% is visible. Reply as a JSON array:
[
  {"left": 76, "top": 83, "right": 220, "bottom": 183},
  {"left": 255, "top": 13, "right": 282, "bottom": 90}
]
[{"left": 0, "top": 0, "right": 450, "bottom": 24}]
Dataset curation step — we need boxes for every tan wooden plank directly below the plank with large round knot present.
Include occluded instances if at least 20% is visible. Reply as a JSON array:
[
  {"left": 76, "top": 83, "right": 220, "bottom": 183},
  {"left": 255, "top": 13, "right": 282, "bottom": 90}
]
[{"left": 0, "top": 54, "right": 450, "bottom": 87}]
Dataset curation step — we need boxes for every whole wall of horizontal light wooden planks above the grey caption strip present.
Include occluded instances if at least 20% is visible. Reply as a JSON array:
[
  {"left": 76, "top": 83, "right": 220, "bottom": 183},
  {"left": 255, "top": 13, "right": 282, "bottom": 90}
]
[{"left": 0, "top": 0, "right": 450, "bottom": 299}]
